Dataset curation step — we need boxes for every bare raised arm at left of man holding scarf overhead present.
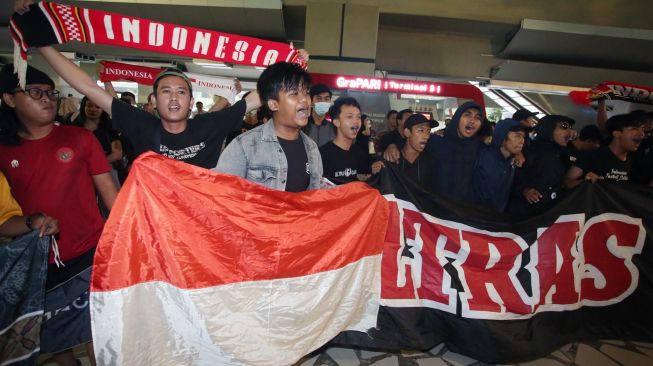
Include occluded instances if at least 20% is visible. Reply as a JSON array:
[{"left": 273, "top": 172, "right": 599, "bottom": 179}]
[{"left": 38, "top": 46, "right": 113, "bottom": 114}]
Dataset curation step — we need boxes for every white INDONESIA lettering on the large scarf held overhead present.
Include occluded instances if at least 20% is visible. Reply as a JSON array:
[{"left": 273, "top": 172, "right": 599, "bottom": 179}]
[{"left": 103, "top": 14, "right": 279, "bottom": 65}]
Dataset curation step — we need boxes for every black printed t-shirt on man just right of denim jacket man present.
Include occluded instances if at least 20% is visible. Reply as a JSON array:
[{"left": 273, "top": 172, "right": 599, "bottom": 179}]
[{"left": 320, "top": 141, "right": 373, "bottom": 184}]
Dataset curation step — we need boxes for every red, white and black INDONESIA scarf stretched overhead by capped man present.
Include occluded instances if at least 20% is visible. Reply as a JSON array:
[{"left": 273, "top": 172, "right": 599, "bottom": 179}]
[{"left": 9, "top": 1, "right": 306, "bottom": 86}]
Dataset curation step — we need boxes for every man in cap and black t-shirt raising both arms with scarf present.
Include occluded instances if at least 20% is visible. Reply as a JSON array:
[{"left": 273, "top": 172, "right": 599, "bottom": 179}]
[{"left": 39, "top": 47, "right": 260, "bottom": 168}]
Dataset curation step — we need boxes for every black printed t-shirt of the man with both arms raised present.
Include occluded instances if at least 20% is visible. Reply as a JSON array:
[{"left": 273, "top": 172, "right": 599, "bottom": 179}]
[{"left": 111, "top": 99, "right": 246, "bottom": 168}]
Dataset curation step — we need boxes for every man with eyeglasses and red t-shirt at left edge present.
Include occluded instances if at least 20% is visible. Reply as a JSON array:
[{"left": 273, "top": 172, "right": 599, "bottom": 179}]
[{"left": 0, "top": 64, "right": 117, "bottom": 365}]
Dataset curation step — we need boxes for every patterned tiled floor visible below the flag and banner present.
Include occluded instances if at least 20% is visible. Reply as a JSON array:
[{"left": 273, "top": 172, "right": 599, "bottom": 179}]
[{"left": 39, "top": 341, "right": 653, "bottom": 366}]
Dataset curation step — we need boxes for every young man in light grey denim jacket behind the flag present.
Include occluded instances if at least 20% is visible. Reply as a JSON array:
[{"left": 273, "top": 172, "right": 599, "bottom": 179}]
[{"left": 213, "top": 62, "right": 322, "bottom": 192}]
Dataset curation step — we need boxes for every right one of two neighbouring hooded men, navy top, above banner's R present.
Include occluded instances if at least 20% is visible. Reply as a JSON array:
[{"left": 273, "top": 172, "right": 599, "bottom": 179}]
[{"left": 472, "top": 119, "right": 527, "bottom": 212}]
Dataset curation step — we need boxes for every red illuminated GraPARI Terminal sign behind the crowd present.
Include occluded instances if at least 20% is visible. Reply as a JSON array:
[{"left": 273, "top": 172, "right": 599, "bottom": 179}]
[{"left": 311, "top": 73, "right": 485, "bottom": 106}]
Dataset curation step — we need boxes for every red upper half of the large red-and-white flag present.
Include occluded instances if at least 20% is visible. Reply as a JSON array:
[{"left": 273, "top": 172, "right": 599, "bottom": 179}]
[{"left": 91, "top": 153, "right": 388, "bottom": 291}]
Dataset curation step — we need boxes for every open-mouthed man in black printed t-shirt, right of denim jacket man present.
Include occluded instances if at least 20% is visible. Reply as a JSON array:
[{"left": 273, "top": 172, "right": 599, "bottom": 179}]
[{"left": 320, "top": 97, "right": 383, "bottom": 184}]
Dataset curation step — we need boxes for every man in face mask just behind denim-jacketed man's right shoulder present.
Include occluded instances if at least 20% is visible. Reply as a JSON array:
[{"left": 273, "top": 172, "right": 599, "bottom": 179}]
[{"left": 304, "top": 84, "right": 336, "bottom": 147}]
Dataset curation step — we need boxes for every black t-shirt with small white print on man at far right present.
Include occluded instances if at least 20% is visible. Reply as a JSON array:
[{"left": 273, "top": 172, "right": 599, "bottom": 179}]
[{"left": 577, "top": 146, "right": 631, "bottom": 182}]
